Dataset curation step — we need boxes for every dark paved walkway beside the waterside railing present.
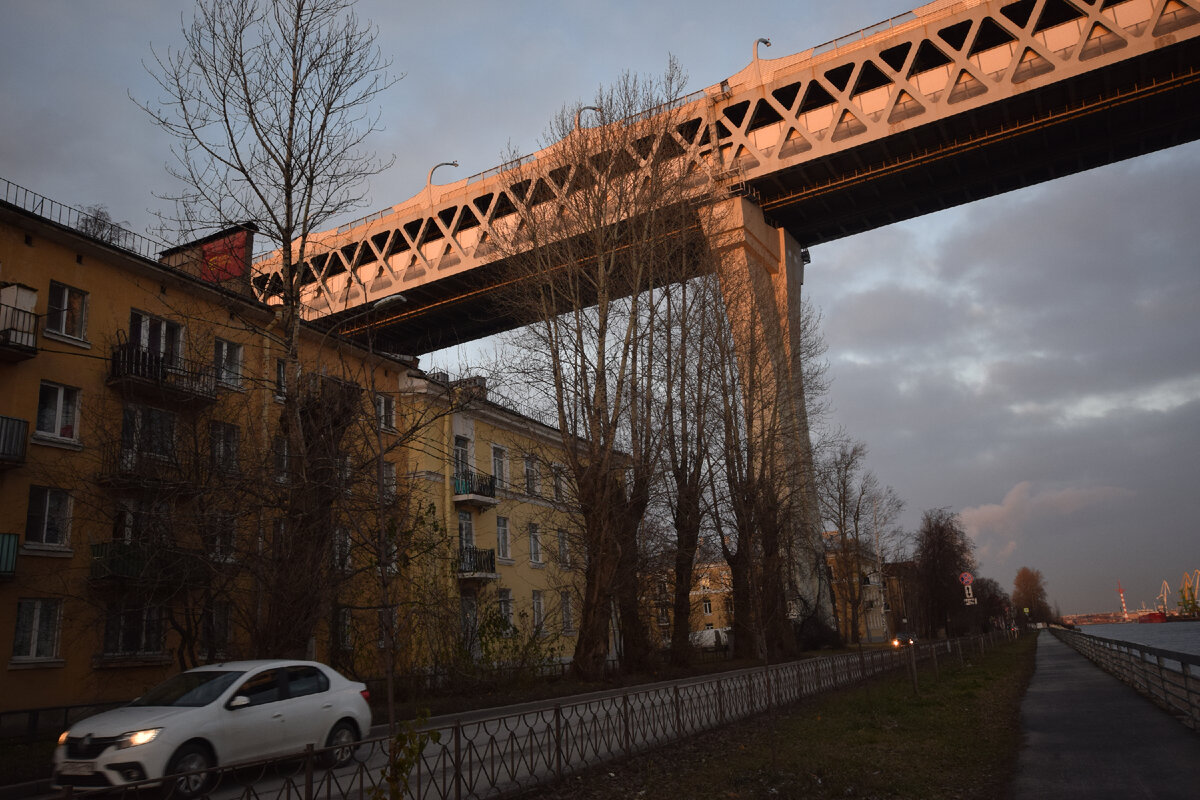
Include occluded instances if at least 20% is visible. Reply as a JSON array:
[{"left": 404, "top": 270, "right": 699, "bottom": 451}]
[{"left": 1012, "top": 631, "right": 1200, "bottom": 800}]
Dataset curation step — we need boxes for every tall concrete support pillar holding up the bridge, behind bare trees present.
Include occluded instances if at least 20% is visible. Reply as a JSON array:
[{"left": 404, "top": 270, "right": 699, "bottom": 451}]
[{"left": 701, "top": 197, "right": 833, "bottom": 642}]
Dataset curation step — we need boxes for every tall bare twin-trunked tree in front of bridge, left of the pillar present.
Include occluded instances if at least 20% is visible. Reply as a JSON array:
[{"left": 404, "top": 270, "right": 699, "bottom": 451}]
[{"left": 499, "top": 61, "right": 695, "bottom": 678}]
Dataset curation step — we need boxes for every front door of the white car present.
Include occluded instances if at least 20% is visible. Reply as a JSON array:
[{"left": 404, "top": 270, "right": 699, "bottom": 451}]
[{"left": 218, "top": 668, "right": 287, "bottom": 764}]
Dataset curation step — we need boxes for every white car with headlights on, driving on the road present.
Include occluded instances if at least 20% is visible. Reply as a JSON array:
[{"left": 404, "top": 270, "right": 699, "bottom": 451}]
[{"left": 54, "top": 661, "right": 371, "bottom": 798}]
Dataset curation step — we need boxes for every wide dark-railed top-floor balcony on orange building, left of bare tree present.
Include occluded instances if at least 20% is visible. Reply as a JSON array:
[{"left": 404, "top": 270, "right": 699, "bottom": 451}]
[{"left": 108, "top": 342, "right": 217, "bottom": 403}]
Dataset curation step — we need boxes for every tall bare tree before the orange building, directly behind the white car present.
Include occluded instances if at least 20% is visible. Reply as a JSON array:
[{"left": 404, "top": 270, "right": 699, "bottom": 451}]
[{"left": 139, "top": 0, "right": 394, "bottom": 655}]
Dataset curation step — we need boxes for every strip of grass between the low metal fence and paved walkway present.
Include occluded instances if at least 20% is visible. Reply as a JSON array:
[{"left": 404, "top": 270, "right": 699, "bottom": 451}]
[{"left": 521, "top": 636, "right": 1036, "bottom": 800}]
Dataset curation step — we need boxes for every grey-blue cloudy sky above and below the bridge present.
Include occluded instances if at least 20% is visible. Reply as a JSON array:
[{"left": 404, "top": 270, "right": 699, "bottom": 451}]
[{"left": 0, "top": 0, "right": 1200, "bottom": 613}]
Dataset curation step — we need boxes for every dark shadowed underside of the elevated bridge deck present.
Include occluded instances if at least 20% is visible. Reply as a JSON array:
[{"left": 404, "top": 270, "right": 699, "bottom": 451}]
[{"left": 350, "top": 38, "right": 1200, "bottom": 354}]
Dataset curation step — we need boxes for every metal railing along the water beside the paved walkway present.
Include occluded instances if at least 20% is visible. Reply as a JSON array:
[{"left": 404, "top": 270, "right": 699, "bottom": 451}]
[{"left": 1052, "top": 627, "right": 1200, "bottom": 730}]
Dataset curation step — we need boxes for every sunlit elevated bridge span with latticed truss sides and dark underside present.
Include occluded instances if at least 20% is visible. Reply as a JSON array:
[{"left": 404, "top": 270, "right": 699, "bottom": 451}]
[{"left": 256, "top": 0, "right": 1200, "bottom": 353}]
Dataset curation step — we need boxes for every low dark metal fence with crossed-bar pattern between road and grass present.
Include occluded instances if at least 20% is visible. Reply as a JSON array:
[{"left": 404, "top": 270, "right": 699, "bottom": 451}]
[{"left": 54, "top": 633, "right": 1007, "bottom": 800}]
